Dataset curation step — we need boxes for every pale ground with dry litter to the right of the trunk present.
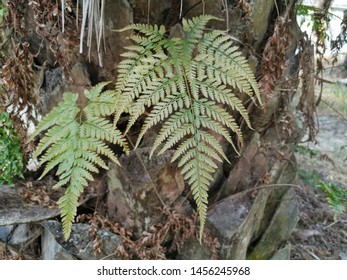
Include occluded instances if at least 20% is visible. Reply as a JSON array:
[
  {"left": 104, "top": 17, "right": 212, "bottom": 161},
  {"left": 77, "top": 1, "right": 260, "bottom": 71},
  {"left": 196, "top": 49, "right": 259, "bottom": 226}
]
[{"left": 290, "top": 66, "right": 347, "bottom": 260}]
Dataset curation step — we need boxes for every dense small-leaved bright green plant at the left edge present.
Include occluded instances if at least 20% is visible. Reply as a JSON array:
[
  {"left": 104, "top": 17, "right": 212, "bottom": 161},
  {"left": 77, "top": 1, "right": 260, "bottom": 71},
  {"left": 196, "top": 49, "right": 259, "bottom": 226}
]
[{"left": 0, "top": 112, "right": 23, "bottom": 184}]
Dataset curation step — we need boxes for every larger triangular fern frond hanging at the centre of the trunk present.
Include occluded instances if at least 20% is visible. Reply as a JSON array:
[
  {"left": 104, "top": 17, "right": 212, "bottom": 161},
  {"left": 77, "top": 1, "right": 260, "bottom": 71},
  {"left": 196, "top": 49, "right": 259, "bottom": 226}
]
[{"left": 115, "top": 15, "right": 260, "bottom": 240}]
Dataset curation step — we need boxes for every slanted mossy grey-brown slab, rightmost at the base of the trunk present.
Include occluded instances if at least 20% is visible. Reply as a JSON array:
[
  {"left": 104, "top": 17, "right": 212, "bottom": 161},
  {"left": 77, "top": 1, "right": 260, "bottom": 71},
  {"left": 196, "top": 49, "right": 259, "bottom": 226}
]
[{"left": 249, "top": 188, "right": 299, "bottom": 260}]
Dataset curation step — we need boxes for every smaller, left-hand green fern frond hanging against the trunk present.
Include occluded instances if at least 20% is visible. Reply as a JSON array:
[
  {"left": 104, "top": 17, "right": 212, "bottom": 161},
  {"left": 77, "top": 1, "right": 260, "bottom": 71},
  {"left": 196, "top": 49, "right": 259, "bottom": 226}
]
[{"left": 31, "top": 83, "right": 128, "bottom": 240}]
